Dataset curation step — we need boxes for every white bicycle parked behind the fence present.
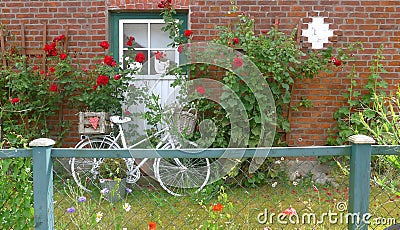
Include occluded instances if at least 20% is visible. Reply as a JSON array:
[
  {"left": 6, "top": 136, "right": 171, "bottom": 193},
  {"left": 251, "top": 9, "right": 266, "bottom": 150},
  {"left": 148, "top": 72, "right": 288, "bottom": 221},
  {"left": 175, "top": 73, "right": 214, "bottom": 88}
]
[{"left": 70, "top": 113, "right": 210, "bottom": 196}]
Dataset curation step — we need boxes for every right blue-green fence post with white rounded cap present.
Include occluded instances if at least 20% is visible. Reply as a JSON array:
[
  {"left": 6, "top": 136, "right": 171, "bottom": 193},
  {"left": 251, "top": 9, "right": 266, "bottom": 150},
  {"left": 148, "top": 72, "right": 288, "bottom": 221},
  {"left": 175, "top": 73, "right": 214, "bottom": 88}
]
[{"left": 347, "top": 135, "right": 375, "bottom": 230}]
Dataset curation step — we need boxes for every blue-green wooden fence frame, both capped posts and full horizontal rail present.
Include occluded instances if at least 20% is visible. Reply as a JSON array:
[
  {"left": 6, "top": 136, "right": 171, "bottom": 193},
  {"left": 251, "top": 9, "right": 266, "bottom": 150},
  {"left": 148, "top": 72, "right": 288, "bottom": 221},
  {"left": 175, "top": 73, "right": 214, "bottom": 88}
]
[{"left": 0, "top": 135, "right": 400, "bottom": 230}]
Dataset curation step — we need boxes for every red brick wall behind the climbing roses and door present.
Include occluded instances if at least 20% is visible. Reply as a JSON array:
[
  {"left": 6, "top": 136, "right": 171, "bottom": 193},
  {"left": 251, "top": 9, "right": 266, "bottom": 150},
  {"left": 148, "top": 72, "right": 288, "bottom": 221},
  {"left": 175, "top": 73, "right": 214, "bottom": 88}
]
[{"left": 0, "top": 0, "right": 400, "bottom": 146}]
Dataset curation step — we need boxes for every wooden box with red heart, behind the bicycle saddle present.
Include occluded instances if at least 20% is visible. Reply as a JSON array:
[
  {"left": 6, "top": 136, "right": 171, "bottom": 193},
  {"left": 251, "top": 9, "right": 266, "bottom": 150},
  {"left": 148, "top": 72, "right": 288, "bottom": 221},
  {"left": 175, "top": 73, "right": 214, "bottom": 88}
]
[{"left": 78, "top": 112, "right": 111, "bottom": 134}]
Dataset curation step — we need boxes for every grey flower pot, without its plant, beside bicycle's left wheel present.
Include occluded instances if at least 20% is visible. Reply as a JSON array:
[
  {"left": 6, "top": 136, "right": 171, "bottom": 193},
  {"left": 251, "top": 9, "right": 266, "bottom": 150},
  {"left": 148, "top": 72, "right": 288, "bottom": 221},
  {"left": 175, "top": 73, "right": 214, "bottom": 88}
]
[{"left": 100, "top": 178, "right": 126, "bottom": 203}]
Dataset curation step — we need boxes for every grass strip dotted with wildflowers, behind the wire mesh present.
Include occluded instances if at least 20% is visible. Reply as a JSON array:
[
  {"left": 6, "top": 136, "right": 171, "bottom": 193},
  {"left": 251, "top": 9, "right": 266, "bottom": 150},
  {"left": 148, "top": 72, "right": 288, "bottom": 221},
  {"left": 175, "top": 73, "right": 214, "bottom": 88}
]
[{"left": 54, "top": 174, "right": 400, "bottom": 230}]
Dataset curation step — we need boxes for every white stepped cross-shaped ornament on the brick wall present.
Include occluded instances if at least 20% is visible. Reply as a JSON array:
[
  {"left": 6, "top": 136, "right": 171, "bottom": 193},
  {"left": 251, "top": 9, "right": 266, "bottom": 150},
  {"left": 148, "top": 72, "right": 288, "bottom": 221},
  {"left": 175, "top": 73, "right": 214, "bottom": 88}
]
[{"left": 302, "top": 17, "right": 333, "bottom": 49}]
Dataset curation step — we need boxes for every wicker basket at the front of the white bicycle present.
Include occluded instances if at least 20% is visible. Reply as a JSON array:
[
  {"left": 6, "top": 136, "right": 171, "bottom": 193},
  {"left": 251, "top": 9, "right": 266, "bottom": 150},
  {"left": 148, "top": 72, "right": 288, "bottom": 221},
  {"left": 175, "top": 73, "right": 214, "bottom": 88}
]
[{"left": 172, "top": 108, "right": 197, "bottom": 135}]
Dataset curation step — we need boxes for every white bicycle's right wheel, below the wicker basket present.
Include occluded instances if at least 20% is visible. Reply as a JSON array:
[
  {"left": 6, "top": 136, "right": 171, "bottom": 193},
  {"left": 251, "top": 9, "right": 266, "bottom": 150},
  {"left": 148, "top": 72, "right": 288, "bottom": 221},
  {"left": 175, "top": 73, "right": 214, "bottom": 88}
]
[{"left": 154, "top": 143, "right": 211, "bottom": 196}]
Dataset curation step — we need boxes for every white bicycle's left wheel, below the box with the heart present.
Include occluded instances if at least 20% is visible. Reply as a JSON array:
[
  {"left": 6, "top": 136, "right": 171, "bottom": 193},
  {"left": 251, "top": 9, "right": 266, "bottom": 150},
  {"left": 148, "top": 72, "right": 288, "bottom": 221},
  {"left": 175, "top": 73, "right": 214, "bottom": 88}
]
[{"left": 71, "top": 138, "right": 120, "bottom": 192}]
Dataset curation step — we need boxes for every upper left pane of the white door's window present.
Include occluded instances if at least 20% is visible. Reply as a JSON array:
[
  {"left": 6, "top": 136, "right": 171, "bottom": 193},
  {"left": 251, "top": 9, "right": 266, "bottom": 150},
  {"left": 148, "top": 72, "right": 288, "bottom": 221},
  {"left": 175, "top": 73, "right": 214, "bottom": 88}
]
[{"left": 124, "top": 23, "right": 149, "bottom": 48}]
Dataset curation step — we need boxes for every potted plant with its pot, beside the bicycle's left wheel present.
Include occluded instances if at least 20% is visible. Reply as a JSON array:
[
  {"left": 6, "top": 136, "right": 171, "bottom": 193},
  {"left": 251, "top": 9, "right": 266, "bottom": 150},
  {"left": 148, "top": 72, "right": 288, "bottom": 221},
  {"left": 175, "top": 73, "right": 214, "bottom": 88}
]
[{"left": 99, "top": 158, "right": 128, "bottom": 202}]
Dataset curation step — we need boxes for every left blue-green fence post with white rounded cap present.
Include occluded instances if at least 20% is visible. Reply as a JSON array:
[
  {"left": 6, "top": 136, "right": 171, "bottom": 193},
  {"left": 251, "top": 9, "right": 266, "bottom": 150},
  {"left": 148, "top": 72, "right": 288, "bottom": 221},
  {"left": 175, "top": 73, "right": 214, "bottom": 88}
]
[{"left": 29, "top": 138, "right": 55, "bottom": 230}]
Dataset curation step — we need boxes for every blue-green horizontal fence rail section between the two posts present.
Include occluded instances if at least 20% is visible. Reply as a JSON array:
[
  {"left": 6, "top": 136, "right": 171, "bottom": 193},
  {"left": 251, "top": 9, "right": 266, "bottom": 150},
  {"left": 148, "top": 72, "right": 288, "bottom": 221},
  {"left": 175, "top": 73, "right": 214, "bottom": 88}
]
[{"left": 52, "top": 146, "right": 350, "bottom": 158}]
